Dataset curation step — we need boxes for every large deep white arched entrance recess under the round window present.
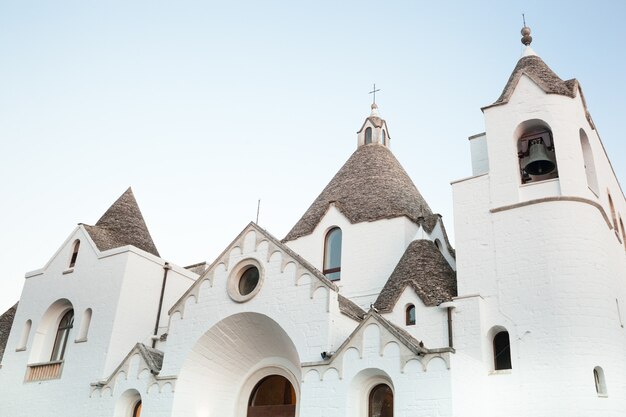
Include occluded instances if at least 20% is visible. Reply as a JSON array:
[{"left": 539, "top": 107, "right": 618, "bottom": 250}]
[{"left": 173, "top": 312, "right": 302, "bottom": 417}]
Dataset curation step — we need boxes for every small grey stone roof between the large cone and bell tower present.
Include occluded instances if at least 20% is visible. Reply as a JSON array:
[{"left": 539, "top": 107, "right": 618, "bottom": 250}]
[{"left": 374, "top": 240, "right": 457, "bottom": 313}]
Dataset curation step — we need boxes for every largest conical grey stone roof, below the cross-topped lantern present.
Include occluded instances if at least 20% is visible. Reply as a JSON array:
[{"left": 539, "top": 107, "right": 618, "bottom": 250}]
[{"left": 284, "top": 144, "right": 433, "bottom": 241}]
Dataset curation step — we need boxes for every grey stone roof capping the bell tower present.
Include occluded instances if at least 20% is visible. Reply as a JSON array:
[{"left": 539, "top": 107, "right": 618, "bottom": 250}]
[{"left": 487, "top": 55, "right": 578, "bottom": 107}]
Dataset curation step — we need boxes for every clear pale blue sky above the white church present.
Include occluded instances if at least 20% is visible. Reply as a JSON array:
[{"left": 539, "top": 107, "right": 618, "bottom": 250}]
[{"left": 0, "top": 0, "right": 626, "bottom": 310}]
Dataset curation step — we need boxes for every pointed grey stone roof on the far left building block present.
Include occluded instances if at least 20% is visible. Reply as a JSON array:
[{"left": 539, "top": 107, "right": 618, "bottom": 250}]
[{"left": 83, "top": 187, "right": 160, "bottom": 256}]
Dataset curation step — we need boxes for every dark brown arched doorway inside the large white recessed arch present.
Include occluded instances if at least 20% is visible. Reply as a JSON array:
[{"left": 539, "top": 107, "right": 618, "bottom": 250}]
[{"left": 248, "top": 375, "right": 296, "bottom": 417}]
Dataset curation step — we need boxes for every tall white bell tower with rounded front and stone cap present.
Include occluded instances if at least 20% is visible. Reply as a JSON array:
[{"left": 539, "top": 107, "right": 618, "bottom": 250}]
[{"left": 452, "top": 26, "right": 626, "bottom": 415}]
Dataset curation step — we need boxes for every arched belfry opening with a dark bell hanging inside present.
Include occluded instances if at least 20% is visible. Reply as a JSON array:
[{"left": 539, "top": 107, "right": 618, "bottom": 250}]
[{"left": 515, "top": 119, "right": 559, "bottom": 184}]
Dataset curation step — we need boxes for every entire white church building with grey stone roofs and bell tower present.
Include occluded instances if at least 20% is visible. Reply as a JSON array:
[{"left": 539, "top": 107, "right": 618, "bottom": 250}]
[{"left": 0, "top": 28, "right": 626, "bottom": 417}]
